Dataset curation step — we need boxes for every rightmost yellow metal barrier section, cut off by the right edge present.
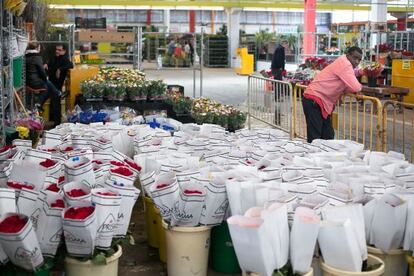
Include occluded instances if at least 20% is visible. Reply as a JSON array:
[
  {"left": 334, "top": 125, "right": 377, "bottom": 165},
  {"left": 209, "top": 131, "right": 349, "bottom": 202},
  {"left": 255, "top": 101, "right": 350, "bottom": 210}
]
[{"left": 382, "top": 101, "right": 414, "bottom": 162}]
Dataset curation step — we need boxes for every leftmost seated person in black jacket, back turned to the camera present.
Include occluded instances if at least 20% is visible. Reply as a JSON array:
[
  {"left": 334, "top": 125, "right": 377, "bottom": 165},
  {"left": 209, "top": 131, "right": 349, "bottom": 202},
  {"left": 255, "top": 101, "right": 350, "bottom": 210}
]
[{"left": 25, "top": 41, "right": 61, "bottom": 114}]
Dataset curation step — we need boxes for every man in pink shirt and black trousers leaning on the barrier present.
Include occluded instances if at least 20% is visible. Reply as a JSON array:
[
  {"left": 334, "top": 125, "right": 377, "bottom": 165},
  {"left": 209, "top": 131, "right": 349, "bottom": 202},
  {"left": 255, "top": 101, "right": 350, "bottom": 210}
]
[{"left": 302, "top": 46, "right": 362, "bottom": 143}]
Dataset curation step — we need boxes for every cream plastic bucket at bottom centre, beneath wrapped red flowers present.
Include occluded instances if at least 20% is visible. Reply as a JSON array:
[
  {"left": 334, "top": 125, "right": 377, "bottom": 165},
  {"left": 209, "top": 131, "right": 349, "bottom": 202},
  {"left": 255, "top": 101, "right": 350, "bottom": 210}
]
[{"left": 163, "top": 221, "right": 211, "bottom": 276}]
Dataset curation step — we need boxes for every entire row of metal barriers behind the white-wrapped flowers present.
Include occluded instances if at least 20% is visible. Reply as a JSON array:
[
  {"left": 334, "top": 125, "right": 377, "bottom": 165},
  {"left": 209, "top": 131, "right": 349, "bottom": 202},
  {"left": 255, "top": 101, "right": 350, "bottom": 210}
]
[{"left": 248, "top": 76, "right": 414, "bottom": 158}]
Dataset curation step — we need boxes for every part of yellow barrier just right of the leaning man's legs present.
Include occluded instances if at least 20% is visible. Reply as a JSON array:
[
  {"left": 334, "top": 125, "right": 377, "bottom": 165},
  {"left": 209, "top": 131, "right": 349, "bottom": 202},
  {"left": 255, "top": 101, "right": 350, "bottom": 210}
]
[{"left": 332, "top": 94, "right": 382, "bottom": 151}]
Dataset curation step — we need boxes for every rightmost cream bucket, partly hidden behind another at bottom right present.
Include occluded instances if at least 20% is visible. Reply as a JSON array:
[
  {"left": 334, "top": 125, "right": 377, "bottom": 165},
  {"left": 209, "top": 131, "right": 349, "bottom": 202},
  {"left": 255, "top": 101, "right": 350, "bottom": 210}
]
[{"left": 367, "top": 246, "right": 408, "bottom": 276}]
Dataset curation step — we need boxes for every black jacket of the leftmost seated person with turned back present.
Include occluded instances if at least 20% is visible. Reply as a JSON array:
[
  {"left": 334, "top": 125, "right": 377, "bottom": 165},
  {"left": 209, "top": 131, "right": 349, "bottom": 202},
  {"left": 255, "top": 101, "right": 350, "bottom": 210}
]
[{"left": 25, "top": 53, "right": 47, "bottom": 89}]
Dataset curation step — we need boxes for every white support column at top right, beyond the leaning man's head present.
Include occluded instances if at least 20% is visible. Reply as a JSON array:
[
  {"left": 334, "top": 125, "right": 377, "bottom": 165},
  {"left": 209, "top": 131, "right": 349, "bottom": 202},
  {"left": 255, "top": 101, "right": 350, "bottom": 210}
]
[{"left": 369, "top": 0, "right": 387, "bottom": 48}]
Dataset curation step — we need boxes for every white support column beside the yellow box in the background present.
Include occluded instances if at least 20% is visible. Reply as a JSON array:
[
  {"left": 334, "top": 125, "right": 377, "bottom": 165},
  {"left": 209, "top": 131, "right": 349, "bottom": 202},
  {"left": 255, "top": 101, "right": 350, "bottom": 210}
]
[{"left": 226, "top": 8, "right": 241, "bottom": 68}]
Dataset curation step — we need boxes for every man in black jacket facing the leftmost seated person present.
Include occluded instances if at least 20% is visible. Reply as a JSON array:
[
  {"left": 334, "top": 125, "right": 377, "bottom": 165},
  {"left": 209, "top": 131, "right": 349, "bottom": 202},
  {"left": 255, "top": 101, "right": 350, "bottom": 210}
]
[{"left": 46, "top": 44, "right": 73, "bottom": 125}]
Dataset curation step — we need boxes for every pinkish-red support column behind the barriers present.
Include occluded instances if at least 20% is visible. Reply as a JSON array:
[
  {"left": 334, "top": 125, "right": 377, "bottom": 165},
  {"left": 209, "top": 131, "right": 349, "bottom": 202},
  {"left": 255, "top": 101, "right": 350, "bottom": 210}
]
[{"left": 303, "top": 0, "right": 316, "bottom": 58}]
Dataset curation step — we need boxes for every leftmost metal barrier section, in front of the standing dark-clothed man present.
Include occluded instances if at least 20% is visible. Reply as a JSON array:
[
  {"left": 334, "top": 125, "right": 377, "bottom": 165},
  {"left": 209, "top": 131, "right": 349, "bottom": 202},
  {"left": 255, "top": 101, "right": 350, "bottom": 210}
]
[{"left": 247, "top": 76, "right": 293, "bottom": 136}]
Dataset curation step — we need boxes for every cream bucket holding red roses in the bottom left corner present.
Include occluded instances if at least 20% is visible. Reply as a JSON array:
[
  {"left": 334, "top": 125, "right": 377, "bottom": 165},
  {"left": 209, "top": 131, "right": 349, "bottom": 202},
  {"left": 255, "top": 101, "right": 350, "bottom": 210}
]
[{"left": 65, "top": 245, "right": 122, "bottom": 276}]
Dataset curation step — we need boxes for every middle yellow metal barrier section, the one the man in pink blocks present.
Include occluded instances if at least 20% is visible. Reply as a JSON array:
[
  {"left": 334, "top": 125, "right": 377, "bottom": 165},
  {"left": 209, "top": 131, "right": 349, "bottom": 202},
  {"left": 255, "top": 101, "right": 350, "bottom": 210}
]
[{"left": 293, "top": 85, "right": 382, "bottom": 150}]
